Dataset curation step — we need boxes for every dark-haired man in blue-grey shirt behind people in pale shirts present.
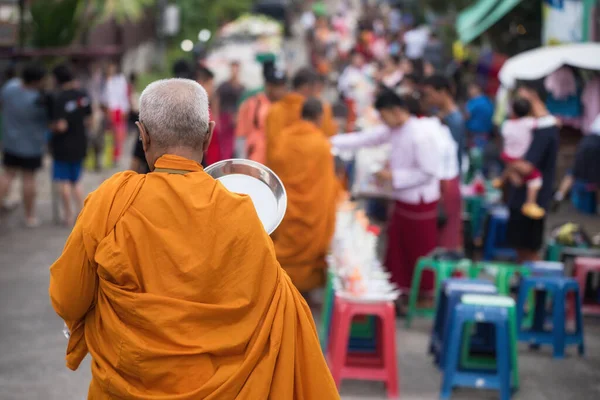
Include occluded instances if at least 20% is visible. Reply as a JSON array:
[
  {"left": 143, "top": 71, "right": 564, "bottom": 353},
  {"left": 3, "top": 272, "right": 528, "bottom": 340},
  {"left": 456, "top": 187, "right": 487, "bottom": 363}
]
[{"left": 423, "top": 75, "right": 467, "bottom": 171}]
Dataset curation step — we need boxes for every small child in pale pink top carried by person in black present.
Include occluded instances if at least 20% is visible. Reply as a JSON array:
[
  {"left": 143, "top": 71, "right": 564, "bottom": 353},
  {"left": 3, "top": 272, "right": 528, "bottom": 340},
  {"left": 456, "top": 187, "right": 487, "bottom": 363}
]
[{"left": 494, "top": 98, "right": 545, "bottom": 219}]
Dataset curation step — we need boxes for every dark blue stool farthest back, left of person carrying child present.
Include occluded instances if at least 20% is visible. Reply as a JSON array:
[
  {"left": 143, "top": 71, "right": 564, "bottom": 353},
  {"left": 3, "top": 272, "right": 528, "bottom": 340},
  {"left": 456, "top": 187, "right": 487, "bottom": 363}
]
[{"left": 483, "top": 207, "right": 517, "bottom": 261}]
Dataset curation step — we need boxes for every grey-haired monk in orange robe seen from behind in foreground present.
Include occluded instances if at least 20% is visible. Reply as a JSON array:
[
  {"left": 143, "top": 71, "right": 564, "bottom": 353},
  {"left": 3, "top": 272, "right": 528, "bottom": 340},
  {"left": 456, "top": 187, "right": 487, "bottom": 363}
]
[{"left": 50, "top": 79, "right": 339, "bottom": 400}]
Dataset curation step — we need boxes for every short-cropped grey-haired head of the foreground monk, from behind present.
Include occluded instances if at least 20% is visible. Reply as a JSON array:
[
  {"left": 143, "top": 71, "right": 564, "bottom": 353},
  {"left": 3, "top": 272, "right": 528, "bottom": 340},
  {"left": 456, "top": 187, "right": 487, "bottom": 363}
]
[{"left": 137, "top": 78, "right": 215, "bottom": 169}]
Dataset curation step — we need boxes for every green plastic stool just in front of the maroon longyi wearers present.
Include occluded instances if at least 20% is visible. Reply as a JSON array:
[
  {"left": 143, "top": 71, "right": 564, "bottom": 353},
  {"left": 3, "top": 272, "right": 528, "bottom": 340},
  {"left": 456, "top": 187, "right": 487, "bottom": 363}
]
[{"left": 406, "top": 257, "right": 478, "bottom": 328}]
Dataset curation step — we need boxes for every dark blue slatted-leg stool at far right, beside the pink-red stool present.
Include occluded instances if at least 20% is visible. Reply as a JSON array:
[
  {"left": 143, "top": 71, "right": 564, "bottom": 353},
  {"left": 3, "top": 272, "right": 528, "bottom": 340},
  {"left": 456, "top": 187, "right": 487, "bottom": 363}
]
[{"left": 517, "top": 277, "right": 585, "bottom": 358}]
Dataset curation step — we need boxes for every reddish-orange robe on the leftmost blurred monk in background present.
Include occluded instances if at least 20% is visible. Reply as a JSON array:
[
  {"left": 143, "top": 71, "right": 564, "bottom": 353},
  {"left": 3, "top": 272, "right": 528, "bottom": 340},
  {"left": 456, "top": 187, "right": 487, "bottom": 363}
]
[{"left": 236, "top": 93, "right": 271, "bottom": 164}]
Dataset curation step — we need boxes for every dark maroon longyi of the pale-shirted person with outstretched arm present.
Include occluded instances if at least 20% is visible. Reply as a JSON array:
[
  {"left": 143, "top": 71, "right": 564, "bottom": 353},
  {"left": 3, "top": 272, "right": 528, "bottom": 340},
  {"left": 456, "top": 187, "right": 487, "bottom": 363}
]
[{"left": 385, "top": 201, "right": 438, "bottom": 291}]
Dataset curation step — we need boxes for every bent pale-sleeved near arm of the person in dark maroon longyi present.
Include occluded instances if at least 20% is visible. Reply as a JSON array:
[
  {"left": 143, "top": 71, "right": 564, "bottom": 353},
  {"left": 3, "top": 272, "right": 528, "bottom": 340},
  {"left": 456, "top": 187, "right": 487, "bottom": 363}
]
[{"left": 392, "top": 133, "right": 439, "bottom": 190}]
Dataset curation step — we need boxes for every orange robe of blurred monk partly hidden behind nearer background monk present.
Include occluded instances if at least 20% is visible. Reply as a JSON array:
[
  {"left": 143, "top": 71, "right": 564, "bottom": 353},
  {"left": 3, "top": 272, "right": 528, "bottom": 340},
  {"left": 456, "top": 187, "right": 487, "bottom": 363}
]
[{"left": 266, "top": 93, "right": 338, "bottom": 166}]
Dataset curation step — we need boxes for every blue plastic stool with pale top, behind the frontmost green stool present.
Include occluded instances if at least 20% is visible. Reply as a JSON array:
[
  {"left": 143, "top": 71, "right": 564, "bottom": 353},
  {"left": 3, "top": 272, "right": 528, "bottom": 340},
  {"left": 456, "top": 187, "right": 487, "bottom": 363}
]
[{"left": 429, "top": 278, "right": 498, "bottom": 366}]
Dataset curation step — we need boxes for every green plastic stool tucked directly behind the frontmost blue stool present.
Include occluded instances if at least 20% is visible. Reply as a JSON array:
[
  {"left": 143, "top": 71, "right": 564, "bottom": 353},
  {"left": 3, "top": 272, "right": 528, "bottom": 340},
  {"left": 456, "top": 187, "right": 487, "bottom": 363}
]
[{"left": 460, "top": 295, "right": 520, "bottom": 389}]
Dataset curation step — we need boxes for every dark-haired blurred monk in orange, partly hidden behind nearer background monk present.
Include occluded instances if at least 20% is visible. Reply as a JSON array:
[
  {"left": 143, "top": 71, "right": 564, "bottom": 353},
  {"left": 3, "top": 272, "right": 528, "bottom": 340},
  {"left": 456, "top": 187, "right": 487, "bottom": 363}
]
[{"left": 266, "top": 68, "right": 337, "bottom": 166}]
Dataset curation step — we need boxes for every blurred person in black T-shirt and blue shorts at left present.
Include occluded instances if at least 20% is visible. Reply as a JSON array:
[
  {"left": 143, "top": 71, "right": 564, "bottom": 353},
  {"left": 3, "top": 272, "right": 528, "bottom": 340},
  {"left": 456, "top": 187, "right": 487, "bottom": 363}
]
[{"left": 50, "top": 65, "right": 92, "bottom": 226}]
